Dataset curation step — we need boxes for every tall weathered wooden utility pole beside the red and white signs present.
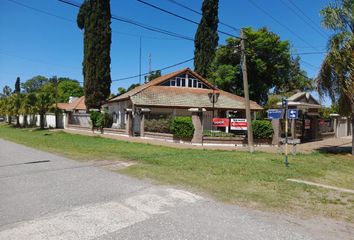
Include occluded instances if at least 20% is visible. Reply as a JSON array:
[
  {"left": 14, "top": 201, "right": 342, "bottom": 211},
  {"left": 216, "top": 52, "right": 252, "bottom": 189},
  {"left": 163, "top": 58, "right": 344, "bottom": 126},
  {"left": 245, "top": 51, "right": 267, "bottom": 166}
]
[{"left": 241, "top": 29, "right": 254, "bottom": 153}]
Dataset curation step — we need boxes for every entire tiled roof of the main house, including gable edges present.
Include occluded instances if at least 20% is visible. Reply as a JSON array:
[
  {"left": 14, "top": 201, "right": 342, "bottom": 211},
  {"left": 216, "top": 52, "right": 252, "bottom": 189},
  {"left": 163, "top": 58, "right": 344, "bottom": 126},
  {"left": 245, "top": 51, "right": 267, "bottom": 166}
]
[{"left": 109, "top": 68, "right": 262, "bottom": 110}]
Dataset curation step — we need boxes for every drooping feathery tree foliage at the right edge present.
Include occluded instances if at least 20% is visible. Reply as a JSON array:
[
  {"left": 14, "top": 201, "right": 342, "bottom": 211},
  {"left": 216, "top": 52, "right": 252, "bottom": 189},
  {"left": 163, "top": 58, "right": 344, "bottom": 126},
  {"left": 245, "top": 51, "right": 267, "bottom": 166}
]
[{"left": 317, "top": 0, "right": 354, "bottom": 155}]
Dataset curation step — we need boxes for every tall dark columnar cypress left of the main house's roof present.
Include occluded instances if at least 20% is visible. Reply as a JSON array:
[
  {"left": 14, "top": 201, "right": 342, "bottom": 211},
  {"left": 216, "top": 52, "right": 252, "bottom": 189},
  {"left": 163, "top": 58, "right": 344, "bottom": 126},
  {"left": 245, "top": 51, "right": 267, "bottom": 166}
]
[{"left": 77, "top": 0, "right": 111, "bottom": 109}]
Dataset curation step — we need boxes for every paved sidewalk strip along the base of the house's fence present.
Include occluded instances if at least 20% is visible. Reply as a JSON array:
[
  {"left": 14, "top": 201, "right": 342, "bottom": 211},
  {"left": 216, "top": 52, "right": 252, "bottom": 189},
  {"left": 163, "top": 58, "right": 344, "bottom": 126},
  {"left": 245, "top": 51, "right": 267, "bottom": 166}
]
[{"left": 63, "top": 128, "right": 351, "bottom": 153}]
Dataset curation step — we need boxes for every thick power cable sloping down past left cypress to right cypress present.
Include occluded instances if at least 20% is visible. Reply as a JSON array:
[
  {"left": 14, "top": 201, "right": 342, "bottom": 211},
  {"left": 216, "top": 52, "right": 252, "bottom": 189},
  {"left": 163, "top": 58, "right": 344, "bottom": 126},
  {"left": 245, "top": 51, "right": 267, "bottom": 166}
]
[{"left": 58, "top": 0, "right": 194, "bottom": 41}]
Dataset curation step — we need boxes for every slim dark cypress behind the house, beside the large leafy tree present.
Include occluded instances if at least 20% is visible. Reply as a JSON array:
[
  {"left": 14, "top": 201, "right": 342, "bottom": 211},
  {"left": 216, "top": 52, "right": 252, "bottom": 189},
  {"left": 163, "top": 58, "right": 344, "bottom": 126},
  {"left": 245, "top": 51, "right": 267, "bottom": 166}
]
[{"left": 194, "top": 0, "right": 219, "bottom": 77}]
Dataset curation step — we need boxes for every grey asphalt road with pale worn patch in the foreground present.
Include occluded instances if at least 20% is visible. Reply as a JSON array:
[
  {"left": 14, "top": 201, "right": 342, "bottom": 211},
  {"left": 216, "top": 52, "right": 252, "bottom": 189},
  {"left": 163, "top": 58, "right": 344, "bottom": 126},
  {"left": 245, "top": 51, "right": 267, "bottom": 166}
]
[{"left": 0, "top": 139, "right": 353, "bottom": 240}]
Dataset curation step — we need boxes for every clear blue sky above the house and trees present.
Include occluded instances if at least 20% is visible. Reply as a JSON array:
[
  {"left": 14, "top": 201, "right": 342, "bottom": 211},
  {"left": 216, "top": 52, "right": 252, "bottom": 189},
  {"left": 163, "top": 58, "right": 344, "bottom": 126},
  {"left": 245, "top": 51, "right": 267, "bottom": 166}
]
[{"left": 0, "top": 0, "right": 334, "bottom": 105}]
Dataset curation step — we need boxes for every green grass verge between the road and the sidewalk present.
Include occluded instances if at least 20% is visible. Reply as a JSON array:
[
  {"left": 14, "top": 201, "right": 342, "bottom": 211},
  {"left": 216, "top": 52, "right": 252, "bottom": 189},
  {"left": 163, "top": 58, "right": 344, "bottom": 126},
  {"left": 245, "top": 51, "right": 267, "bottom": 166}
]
[{"left": 0, "top": 125, "right": 354, "bottom": 223}]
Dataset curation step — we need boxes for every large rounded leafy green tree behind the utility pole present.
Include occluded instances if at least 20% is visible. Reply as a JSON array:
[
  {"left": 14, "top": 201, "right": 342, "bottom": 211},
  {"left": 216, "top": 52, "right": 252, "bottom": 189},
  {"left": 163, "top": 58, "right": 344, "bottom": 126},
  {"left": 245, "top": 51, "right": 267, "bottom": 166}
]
[{"left": 209, "top": 28, "right": 311, "bottom": 104}]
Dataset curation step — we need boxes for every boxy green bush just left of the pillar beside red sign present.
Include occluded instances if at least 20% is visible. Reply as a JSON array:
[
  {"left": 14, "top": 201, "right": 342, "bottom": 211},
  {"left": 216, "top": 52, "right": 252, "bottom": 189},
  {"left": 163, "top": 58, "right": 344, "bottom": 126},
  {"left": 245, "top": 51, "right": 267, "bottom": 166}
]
[{"left": 171, "top": 117, "right": 194, "bottom": 138}]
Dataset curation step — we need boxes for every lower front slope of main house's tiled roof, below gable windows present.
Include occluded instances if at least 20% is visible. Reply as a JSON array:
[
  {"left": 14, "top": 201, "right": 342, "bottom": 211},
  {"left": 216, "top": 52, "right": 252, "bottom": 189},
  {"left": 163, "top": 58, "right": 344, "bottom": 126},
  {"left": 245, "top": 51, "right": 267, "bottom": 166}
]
[{"left": 131, "top": 86, "right": 262, "bottom": 110}]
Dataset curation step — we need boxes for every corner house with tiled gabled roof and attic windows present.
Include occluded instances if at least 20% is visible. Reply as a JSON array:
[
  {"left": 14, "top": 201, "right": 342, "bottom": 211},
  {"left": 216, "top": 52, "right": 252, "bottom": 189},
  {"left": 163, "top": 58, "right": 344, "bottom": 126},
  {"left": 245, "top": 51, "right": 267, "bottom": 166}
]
[{"left": 105, "top": 68, "right": 262, "bottom": 133}]
